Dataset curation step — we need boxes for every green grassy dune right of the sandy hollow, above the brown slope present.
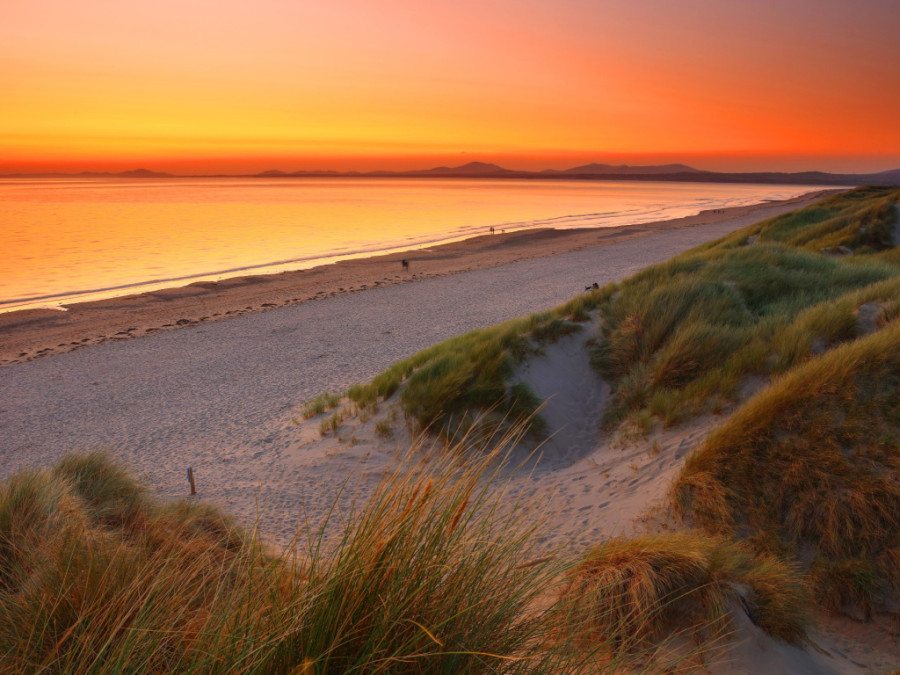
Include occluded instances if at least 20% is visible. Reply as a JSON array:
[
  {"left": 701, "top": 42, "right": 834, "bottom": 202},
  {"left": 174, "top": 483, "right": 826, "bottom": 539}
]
[{"left": 593, "top": 188, "right": 900, "bottom": 425}]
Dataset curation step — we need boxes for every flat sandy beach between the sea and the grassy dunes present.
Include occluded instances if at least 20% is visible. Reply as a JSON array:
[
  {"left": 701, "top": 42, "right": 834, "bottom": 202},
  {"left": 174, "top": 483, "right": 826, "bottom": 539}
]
[{"left": 0, "top": 190, "right": 832, "bottom": 512}]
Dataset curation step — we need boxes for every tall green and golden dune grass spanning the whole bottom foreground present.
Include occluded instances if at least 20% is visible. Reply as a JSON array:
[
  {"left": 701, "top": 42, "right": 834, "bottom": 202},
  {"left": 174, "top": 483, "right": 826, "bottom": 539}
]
[{"left": 0, "top": 444, "right": 805, "bottom": 675}]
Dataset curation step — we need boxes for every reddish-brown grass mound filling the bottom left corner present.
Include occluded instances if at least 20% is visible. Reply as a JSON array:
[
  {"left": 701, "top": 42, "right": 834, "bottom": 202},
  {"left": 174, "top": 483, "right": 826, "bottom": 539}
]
[{"left": 0, "top": 454, "right": 284, "bottom": 673}]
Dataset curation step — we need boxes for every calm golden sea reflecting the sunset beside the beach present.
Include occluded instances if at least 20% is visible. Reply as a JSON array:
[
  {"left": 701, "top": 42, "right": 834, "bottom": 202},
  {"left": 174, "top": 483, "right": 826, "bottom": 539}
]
[{"left": 0, "top": 178, "right": 811, "bottom": 311}]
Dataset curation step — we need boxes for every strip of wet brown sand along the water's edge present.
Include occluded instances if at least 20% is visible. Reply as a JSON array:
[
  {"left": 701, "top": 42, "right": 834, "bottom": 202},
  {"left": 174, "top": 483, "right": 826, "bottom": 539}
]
[{"left": 0, "top": 189, "right": 837, "bottom": 367}]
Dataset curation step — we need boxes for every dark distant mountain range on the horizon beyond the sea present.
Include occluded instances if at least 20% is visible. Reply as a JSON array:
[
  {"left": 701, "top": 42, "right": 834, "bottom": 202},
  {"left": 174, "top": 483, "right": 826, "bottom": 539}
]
[{"left": 3, "top": 162, "right": 900, "bottom": 185}]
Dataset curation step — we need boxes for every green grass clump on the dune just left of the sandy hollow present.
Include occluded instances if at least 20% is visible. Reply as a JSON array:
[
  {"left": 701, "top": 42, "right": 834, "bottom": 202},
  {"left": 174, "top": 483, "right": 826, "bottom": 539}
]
[{"left": 347, "top": 296, "right": 609, "bottom": 436}]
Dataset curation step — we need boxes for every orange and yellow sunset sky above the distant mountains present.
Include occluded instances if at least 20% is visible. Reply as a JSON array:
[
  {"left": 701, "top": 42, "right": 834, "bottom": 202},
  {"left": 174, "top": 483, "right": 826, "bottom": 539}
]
[{"left": 0, "top": 0, "right": 900, "bottom": 173}]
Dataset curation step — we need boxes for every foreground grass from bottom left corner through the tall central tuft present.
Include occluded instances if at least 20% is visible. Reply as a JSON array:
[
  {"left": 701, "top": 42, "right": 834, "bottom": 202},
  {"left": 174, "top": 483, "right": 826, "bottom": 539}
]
[{"left": 0, "top": 453, "right": 620, "bottom": 674}]
